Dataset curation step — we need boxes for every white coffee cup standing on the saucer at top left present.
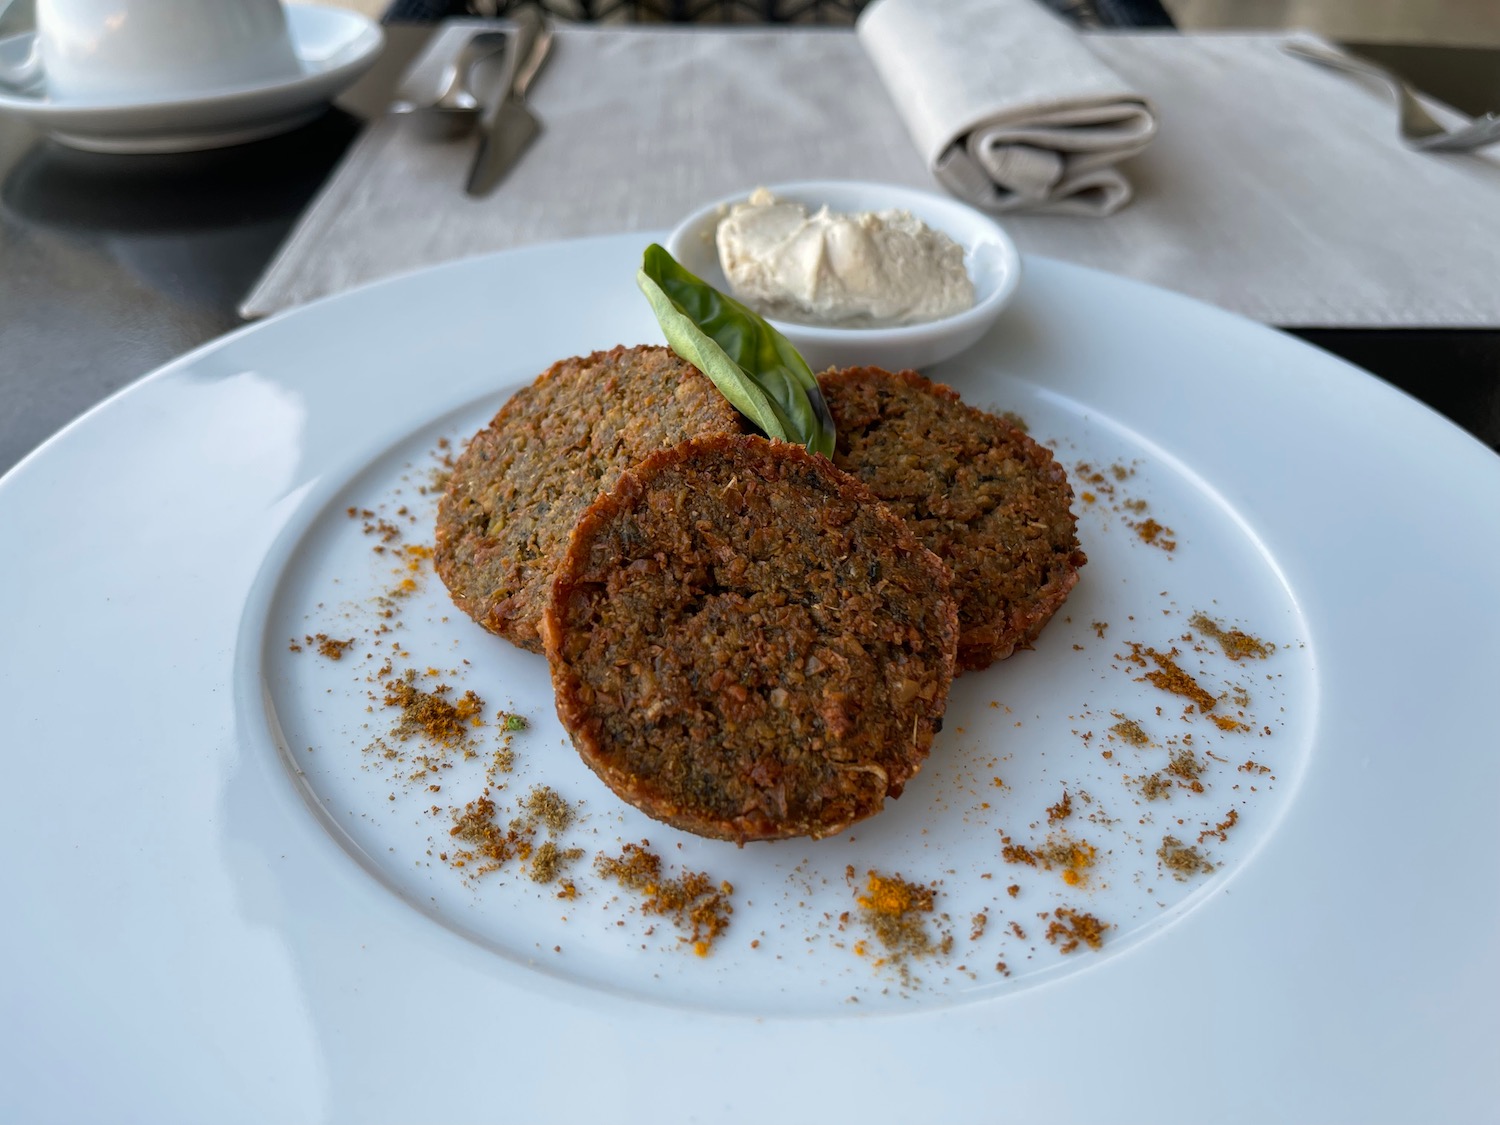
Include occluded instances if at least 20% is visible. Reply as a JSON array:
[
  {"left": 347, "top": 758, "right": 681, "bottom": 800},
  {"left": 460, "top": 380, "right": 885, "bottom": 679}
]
[{"left": 6, "top": 0, "right": 302, "bottom": 102}]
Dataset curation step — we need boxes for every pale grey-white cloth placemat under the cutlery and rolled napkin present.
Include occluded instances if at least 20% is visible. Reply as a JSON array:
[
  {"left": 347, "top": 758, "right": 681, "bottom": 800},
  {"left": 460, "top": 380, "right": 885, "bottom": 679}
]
[{"left": 242, "top": 27, "right": 1500, "bottom": 327}]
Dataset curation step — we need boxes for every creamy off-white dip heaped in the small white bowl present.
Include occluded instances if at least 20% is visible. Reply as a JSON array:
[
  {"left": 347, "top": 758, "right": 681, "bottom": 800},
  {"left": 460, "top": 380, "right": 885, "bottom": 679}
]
[{"left": 717, "top": 188, "right": 974, "bottom": 327}]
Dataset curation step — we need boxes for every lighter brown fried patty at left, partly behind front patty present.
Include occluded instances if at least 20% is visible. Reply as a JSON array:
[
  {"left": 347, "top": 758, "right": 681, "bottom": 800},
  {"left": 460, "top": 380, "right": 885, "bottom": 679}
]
[{"left": 434, "top": 347, "right": 744, "bottom": 653}]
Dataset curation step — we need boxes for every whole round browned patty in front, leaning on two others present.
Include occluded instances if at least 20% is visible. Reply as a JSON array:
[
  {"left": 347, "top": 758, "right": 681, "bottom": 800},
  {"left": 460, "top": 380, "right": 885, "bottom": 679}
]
[{"left": 543, "top": 437, "right": 959, "bottom": 843}]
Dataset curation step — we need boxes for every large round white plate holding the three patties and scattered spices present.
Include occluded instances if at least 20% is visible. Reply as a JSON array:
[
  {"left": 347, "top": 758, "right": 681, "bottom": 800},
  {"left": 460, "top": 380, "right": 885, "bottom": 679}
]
[{"left": 0, "top": 234, "right": 1500, "bottom": 1122}]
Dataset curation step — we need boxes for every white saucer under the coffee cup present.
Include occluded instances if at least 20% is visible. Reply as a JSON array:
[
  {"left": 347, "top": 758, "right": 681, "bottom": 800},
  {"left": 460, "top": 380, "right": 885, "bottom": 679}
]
[{"left": 0, "top": 5, "right": 384, "bottom": 153}]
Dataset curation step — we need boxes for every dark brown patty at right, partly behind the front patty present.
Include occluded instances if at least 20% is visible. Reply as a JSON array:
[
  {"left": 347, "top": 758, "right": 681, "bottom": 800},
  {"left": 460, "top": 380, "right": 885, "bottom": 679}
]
[{"left": 818, "top": 368, "right": 1086, "bottom": 671}]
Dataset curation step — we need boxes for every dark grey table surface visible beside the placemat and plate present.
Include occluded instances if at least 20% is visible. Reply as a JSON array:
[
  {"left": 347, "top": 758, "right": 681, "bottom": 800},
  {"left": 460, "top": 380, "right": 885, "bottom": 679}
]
[{"left": 0, "top": 27, "right": 1500, "bottom": 473}]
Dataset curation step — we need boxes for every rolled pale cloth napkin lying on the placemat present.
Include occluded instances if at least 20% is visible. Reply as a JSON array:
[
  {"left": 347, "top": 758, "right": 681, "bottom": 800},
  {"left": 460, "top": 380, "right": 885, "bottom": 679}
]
[{"left": 858, "top": 0, "right": 1157, "bottom": 215}]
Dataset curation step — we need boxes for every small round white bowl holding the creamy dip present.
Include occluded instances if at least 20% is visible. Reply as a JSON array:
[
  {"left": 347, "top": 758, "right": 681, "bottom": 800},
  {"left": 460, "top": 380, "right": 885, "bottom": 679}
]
[{"left": 666, "top": 180, "right": 1022, "bottom": 371}]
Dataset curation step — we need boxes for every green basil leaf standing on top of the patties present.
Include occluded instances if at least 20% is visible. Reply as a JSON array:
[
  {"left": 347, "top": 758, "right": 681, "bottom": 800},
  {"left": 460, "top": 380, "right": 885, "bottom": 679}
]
[{"left": 636, "top": 243, "right": 834, "bottom": 458}]
